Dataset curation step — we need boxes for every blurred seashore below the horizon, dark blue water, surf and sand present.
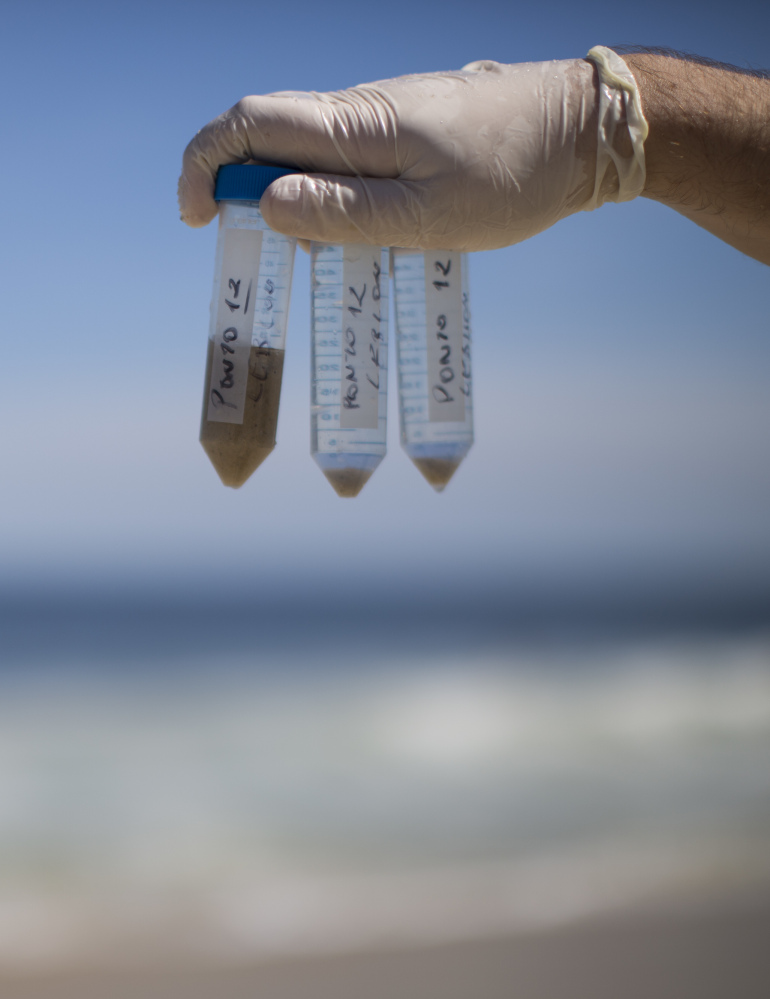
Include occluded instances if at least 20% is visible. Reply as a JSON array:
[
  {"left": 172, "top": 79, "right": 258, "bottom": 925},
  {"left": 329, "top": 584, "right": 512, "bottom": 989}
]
[{"left": 0, "top": 597, "right": 770, "bottom": 999}]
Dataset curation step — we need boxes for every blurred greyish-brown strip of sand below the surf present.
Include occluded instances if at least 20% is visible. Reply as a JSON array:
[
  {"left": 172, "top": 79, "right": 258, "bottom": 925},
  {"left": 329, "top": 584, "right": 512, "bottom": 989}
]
[{"left": 0, "top": 890, "right": 770, "bottom": 999}]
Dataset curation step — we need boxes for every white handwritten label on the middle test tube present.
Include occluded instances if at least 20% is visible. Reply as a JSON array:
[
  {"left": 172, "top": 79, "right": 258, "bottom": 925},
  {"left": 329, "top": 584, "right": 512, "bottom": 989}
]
[{"left": 340, "top": 246, "right": 387, "bottom": 430}]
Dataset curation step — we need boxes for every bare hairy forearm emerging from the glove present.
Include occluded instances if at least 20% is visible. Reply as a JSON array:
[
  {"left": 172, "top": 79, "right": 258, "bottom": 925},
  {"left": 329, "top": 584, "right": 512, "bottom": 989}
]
[{"left": 623, "top": 53, "right": 770, "bottom": 264}]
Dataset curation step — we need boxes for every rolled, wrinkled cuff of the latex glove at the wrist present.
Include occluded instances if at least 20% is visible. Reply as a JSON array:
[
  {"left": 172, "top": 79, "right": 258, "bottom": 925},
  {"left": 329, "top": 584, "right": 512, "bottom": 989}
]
[{"left": 585, "top": 45, "right": 649, "bottom": 211}]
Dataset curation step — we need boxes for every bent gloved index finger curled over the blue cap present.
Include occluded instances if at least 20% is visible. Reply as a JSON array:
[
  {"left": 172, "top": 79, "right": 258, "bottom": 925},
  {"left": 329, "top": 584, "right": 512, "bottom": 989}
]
[{"left": 179, "top": 88, "right": 397, "bottom": 226}]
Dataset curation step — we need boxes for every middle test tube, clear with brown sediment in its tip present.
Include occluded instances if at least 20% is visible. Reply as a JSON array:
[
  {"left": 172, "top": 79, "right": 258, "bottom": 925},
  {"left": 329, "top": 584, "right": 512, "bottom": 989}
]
[{"left": 310, "top": 243, "right": 390, "bottom": 496}]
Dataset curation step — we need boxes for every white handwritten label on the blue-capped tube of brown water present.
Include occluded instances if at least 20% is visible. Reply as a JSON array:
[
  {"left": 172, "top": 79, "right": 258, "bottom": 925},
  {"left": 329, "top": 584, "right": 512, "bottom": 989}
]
[{"left": 206, "top": 229, "right": 262, "bottom": 423}]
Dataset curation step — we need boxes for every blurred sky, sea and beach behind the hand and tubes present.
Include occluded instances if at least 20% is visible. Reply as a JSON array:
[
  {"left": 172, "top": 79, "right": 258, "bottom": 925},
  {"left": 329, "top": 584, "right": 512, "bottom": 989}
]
[{"left": 0, "top": 0, "right": 770, "bottom": 999}]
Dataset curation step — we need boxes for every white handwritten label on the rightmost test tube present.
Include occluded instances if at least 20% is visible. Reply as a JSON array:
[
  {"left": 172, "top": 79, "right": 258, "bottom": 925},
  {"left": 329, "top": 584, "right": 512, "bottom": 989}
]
[{"left": 425, "top": 253, "right": 464, "bottom": 423}]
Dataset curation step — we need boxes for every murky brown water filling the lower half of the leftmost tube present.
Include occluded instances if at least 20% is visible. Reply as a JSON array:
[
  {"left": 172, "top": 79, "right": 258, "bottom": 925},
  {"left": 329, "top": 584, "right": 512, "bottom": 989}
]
[{"left": 200, "top": 340, "right": 284, "bottom": 489}]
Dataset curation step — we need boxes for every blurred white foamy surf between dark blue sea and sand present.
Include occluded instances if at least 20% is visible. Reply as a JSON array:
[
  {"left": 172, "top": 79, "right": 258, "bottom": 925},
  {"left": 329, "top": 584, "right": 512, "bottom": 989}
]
[{"left": 0, "top": 640, "right": 770, "bottom": 971}]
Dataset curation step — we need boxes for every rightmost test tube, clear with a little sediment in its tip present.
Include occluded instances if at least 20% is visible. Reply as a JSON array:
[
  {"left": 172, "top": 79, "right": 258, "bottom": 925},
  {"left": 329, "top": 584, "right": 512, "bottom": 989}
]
[{"left": 392, "top": 249, "right": 473, "bottom": 492}]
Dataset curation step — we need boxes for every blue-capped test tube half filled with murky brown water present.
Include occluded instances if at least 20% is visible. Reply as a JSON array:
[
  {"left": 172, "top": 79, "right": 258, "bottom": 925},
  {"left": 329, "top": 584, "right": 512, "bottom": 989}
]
[{"left": 200, "top": 165, "right": 297, "bottom": 489}]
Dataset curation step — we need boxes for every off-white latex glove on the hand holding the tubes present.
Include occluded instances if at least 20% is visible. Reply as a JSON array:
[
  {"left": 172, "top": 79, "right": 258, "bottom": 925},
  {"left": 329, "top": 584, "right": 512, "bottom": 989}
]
[{"left": 179, "top": 50, "right": 644, "bottom": 250}]
